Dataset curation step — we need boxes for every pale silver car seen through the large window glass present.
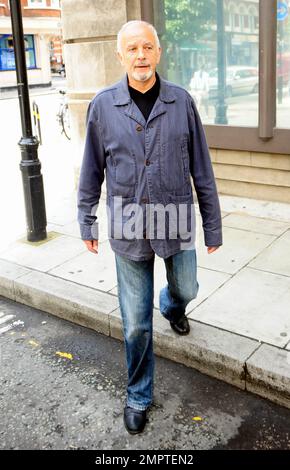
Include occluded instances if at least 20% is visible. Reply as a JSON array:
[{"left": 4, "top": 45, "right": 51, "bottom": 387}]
[{"left": 209, "top": 65, "right": 259, "bottom": 98}]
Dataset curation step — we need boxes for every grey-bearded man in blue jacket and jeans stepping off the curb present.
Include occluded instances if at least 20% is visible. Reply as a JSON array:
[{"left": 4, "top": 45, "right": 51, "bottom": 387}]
[{"left": 78, "top": 21, "right": 222, "bottom": 434}]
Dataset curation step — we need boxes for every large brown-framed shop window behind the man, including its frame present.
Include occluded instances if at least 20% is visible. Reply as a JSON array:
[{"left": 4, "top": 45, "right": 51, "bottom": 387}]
[{"left": 150, "top": 0, "right": 290, "bottom": 154}]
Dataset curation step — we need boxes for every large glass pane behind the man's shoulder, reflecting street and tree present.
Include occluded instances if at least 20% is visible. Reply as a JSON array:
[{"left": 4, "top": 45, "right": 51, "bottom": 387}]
[{"left": 154, "top": 0, "right": 259, "bottom": 126}]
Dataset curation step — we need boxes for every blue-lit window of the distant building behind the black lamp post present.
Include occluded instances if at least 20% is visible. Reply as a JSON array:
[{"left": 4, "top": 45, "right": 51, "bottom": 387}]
[{"left": 0, "top": 34, "right": 36, "bottom": 71}]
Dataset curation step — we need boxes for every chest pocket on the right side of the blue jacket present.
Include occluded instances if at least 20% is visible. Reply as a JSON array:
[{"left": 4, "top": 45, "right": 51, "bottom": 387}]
[{"left": 160, "top": 137, "right": 189, "bottom": 191}]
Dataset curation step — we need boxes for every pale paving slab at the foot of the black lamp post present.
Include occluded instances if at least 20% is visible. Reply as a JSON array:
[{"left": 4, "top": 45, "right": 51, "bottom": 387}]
[{"left": 0, "top": 235, "right": 86, "bottom": 272}]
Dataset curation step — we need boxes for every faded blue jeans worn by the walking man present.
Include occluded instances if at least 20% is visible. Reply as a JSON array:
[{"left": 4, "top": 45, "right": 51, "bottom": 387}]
[{"left": 115, "top": 250, "right": 199, "bottom": 410}]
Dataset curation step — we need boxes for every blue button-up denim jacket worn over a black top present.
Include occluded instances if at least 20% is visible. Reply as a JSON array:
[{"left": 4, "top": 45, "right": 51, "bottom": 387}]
[{"left": 78, "top": 76, "right": 222, "bottom": 261}]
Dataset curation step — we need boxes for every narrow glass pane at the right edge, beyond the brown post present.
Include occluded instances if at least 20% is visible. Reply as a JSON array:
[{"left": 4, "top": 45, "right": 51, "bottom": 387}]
[{"left": 276, "top": 0, "right": 290, "bottom": 129}]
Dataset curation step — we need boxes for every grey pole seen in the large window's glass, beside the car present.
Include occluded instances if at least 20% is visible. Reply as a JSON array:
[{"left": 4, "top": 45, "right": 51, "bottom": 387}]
[{"left": 215, "top": 0, "right": 228, "bottom": 124}]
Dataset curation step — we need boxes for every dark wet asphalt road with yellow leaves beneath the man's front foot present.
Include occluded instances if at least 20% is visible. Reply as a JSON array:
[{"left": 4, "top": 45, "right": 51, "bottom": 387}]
[{"left": 0, "top": 297, "right": 290, "bottom": 450}]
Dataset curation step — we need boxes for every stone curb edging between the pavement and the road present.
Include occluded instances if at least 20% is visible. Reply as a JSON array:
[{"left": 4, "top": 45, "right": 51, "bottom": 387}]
[{"left": 0, "top": 259, "right": 290, "bottom": 408}]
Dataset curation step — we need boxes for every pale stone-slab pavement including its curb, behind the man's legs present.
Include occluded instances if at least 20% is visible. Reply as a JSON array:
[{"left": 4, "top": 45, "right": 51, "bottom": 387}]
[{"left": 0, "top": 193, "right": 290, "bottom": 408}]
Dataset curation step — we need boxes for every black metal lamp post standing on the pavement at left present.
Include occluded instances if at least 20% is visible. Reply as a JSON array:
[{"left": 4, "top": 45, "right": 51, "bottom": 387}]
[{"left": 10, "top": 0, "right": 47, "bottom": 241}]
